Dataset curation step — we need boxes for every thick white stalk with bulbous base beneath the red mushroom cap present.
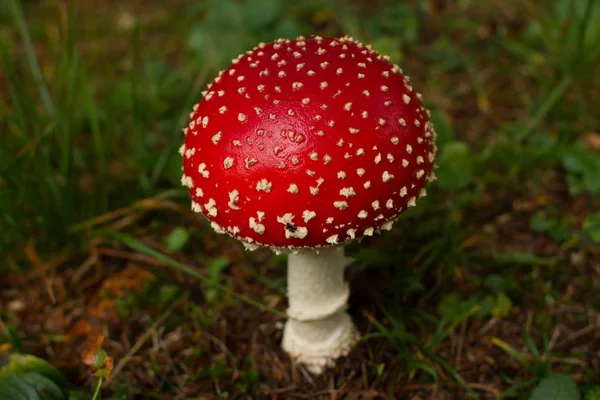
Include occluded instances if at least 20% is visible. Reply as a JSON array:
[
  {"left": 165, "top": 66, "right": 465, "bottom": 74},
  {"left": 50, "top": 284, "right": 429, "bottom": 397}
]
[{"left": 282, "top": 247, "right": 358, "bottom": 374}]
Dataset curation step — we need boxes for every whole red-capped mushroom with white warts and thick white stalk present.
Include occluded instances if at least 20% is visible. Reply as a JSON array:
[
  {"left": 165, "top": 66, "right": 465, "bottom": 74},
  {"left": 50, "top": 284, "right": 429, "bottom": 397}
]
[{"left": 180, "top": 36, "right": 437, "bottom": 373}]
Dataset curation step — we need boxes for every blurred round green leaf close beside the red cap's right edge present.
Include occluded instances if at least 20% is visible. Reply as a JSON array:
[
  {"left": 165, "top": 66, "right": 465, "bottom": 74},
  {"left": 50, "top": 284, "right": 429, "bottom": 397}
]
[{"left": 435, "top": 141, "right": 474, "bottom": 190}]
